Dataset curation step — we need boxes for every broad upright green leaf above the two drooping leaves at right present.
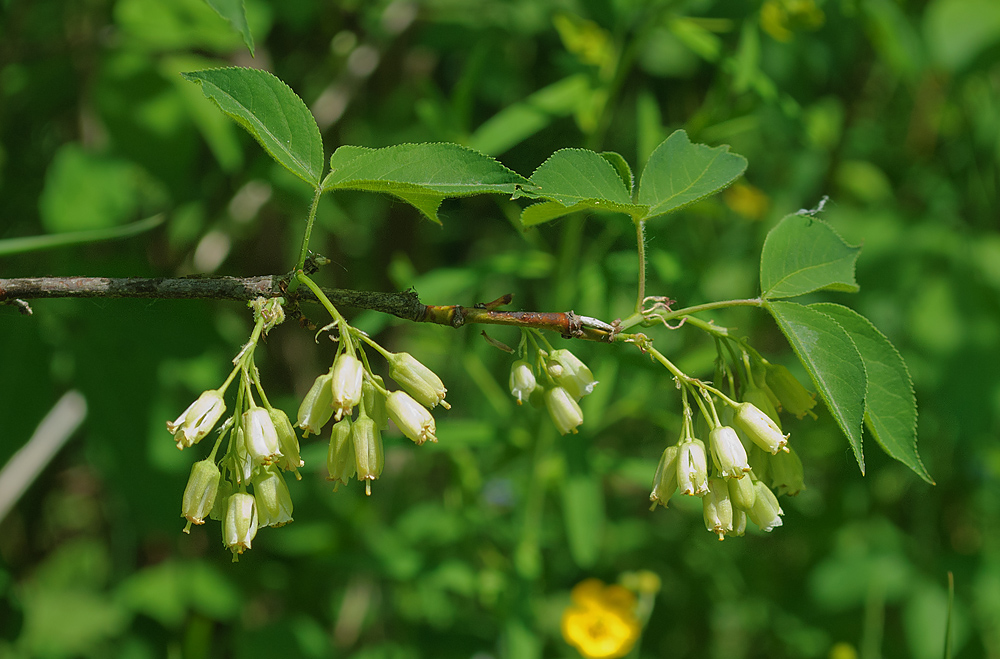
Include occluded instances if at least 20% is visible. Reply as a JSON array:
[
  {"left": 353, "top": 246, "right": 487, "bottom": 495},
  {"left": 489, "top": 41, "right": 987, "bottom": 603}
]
[{"left": 760, "top": 214, "right": 861, "bottom": 300}]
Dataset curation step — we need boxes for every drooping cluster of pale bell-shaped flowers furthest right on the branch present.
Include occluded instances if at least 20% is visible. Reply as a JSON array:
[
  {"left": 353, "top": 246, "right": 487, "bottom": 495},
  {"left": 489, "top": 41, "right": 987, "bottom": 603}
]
[{"left": 649, "top": 358, "right": 815, "bottom": 540}]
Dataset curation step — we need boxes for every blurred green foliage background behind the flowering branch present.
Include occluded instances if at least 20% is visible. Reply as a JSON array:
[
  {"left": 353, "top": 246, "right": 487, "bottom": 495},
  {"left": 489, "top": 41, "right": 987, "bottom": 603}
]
[{"left": 0, "top": 0, "right": 1000, "bottom": 659}]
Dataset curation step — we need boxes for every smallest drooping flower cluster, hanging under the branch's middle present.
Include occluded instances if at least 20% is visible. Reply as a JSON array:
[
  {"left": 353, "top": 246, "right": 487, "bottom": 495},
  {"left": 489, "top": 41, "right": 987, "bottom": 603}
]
[{"left": 510, "top": 332, "right": 598, "bottom": 435}]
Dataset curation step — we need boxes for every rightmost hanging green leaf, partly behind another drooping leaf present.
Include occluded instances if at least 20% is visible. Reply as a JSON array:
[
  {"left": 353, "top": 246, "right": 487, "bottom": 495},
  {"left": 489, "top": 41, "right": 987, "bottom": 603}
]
[{"left": 809, "top": 303, "right": 934, "bottom": 485}]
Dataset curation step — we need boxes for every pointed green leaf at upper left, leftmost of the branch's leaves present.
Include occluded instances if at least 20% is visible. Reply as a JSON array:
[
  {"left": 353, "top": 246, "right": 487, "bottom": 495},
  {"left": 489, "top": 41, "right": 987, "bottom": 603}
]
[{"left": 181, "top": 67, "right": 323, "bottom": 187}]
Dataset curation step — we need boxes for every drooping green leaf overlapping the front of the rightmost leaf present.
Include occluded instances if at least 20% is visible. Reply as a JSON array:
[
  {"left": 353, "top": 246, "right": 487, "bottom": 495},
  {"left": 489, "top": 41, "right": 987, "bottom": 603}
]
[{"left": 765, "top": 301, "right": 868, "bottom": 474}]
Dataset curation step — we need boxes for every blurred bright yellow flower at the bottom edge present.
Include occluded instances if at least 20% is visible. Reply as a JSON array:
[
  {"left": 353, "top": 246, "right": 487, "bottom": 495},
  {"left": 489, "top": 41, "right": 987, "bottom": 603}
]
[{"left": 560, "top": 579, "right": 640, "bottom": 659}]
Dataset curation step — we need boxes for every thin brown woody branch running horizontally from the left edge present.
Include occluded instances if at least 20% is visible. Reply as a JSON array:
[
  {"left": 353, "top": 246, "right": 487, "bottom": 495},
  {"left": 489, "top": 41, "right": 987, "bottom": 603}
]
[{"left": 0, "top": 275, "right": 615, "bottom": 342}]
